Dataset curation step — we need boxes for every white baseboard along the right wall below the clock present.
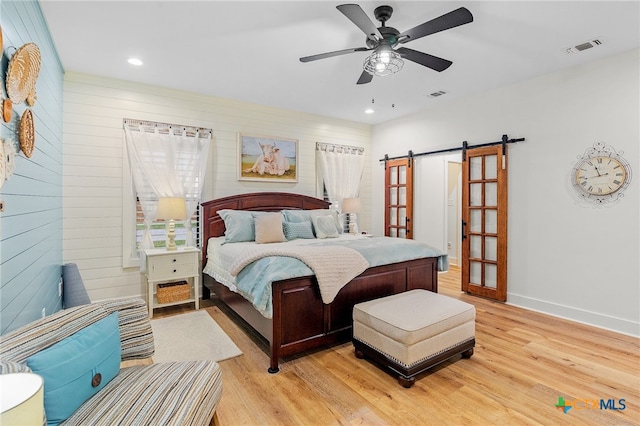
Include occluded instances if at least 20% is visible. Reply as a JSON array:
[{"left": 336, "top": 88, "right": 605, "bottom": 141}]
[{"left": 506, "top": 293, "right": 640, "bottom": 337}]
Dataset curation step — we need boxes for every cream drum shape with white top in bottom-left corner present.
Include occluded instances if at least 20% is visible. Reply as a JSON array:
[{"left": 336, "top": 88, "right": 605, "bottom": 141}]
[{"left": 0, "top": 373, "right": 44, "bottom": 426}]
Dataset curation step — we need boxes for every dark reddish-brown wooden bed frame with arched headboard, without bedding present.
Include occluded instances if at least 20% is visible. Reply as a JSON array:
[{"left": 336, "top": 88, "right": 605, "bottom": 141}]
[{"left": 202, "top": 192, "right": 438, "bottom": 373}]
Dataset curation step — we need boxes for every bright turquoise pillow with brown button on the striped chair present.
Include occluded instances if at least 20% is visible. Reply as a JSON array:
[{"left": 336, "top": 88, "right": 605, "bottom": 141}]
[{"left": 27, "top": 312, "right": 121, "bottom": 425}]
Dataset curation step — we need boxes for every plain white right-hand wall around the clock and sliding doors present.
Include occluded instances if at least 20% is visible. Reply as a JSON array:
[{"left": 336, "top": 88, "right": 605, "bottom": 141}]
[{"left": 372, "top": 50, "right": 640, "bottom": 335}]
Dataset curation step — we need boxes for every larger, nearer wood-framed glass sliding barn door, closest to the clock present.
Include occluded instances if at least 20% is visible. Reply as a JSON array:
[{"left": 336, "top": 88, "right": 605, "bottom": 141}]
[{"left": 461, "top": 145, "right": 507, "bottom": 302}]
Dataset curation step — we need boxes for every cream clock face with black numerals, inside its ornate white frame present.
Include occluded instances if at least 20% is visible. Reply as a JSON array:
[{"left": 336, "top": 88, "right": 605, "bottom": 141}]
[{"left": 574, "top": 155, "right": 627, "bottom": 196}]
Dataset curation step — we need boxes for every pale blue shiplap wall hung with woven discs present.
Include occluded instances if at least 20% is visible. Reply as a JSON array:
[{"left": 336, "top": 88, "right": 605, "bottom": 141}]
[{"left": 0, "top": 0, "right": 64, "bottom": 334}]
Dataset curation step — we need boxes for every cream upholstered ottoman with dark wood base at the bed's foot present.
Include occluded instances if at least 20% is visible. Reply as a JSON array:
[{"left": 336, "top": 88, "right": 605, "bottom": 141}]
[{"left": 353, "top": 290, "right": 476, "bottom": 388}]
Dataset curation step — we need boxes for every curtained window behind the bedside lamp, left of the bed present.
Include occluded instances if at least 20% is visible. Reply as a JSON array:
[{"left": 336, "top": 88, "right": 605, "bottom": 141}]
[{"left": 122, "top": 119, "right": 212, "bottom": 268}]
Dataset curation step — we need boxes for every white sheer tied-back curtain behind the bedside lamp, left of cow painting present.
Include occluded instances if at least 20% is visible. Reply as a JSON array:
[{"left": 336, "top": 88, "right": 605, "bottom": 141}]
[{"left": 124, "top": 120, "right": 212, "bottom": 249}]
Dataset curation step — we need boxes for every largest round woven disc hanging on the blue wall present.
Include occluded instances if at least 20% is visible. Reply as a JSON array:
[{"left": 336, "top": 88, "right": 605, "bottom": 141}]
[{"left": 7, "top": 43, "right": 40, "bottom": 104}]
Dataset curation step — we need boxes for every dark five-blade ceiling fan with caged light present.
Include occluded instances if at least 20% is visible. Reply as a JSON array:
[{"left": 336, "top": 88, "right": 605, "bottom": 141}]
[{"left": 300, "top": 4, "right": 473, "bottom": 84}]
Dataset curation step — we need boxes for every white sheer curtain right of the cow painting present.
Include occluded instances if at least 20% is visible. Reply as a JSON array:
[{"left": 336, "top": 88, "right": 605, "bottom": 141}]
[{"left": 316, "top": 143, "right": 364, "bottom": 211}]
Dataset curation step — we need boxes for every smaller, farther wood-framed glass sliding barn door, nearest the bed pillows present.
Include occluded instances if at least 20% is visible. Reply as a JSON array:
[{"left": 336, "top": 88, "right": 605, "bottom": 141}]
[{"left": 384, "top": 157, "right": 413, "bottom": 239}]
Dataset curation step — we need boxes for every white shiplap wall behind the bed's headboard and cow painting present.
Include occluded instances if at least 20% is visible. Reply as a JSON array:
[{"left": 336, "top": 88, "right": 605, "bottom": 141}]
[{"left": 63, "top": 73, "right": 371, "bottom": 300}]
